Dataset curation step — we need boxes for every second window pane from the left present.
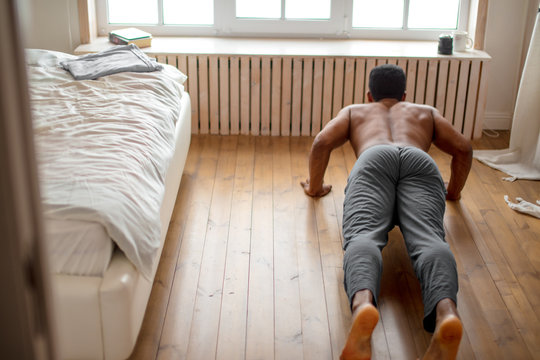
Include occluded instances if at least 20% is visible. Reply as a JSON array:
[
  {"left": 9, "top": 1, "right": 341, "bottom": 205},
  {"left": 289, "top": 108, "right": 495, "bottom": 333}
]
[{"left": 163, "top": 0, "right": 214, "bottom": 25}]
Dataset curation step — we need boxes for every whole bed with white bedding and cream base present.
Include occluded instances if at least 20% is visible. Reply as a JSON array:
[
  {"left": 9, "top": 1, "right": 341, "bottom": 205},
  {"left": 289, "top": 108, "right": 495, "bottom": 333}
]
[{"left": 26, "top": 50, "right": 191, "bottom": 359}]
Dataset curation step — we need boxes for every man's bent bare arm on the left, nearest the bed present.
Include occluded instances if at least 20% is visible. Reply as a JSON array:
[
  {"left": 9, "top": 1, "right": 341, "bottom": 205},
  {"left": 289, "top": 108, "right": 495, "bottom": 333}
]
[{"left": 300, "top": 108, "right": 350, "bottom": 197}]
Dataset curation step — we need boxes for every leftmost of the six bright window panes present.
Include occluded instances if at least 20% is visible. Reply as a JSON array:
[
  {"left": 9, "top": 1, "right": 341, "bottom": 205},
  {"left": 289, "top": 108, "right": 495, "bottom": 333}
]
[{"left": 107, "top": 0, "right": 158, "bottom": 24}]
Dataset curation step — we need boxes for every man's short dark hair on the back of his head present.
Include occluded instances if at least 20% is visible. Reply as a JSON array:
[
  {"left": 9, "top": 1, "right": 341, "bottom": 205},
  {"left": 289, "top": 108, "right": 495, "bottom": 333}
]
[{"left": 369, "top": 64, "right": 406, "bottom": 101}]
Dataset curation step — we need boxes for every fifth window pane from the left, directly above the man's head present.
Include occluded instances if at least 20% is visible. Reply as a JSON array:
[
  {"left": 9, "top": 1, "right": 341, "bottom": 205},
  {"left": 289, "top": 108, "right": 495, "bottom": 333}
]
[{"left": 352, "top": 0, "right": 403, "bottom": 28}]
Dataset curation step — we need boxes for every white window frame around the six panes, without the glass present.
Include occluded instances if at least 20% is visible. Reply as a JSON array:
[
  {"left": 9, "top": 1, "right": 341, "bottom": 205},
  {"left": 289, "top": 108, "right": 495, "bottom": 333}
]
[{"left": 95, "top": 0, "right": 471, "bottom": 40}]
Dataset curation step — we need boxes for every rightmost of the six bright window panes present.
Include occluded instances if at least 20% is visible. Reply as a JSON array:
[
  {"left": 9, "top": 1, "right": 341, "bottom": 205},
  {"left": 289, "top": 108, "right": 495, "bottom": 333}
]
[{"left": 408, "top": 0, "right": 459, "bottom": 29}]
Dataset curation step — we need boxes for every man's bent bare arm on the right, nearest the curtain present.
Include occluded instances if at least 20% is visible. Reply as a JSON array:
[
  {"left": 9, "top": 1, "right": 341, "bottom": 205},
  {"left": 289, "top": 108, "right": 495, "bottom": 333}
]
[{"left": 433, "top": 109, "right": 472, "bottom": 200}]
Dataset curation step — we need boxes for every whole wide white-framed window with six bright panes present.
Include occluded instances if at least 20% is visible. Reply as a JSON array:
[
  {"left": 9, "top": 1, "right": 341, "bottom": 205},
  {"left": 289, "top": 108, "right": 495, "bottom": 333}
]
[{"left": 97, "top": 0, "right": 469, "bottom": 40}]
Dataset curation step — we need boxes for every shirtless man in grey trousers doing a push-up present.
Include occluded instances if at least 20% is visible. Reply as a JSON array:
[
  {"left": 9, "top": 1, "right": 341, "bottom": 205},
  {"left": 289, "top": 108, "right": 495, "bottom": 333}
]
[{"left": 301, "top": 65, "right": 472, "bottom": 360}]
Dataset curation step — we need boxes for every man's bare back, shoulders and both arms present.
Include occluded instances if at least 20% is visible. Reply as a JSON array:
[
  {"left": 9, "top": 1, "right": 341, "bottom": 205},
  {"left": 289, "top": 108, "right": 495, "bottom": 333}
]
[{"left": 302, "top": 93, "right": 472, "bottom": 200}]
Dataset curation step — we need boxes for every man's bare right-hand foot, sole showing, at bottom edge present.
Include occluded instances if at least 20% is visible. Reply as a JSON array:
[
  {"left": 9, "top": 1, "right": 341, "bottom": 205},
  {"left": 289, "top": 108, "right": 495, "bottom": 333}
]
[{"left": 423, "top": 314, "right": 463, "bottom": 360}]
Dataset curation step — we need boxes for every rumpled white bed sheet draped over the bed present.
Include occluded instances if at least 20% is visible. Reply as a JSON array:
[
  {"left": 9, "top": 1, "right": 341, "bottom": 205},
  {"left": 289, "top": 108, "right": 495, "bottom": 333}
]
[{"left": 27, "top": 51, "right": 186, "bottom": 278}]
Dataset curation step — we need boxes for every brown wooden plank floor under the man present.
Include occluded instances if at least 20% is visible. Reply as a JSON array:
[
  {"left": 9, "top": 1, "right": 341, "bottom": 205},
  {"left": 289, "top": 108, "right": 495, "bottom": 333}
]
[{"left": 132, "top": 133, "right": 540, "bottom": 360}]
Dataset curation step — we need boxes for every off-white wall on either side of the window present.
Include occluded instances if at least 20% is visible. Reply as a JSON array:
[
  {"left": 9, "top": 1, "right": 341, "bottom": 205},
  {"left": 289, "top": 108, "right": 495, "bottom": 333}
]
[{"left": 22, "top": 0, "right": 538, "bottom": 129}]
